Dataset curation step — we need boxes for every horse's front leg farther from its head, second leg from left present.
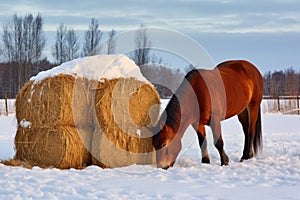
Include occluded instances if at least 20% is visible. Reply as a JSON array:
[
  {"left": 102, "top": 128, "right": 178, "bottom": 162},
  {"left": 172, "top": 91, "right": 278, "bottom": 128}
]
[{"left": 210, "top": 120, "right": 229, "bottom": 165}]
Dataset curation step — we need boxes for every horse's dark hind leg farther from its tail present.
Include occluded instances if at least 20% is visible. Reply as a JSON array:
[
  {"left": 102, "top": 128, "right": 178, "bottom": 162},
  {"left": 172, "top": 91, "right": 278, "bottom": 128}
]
[{"left": 238, "top": 108, "right": 253, "bottom": 161}]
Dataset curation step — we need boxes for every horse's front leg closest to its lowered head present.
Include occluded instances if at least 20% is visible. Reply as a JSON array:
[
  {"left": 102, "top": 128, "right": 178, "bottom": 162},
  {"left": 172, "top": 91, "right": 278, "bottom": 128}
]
[{"left": 193, "top": 125, "right": 210, "bottom": 163}]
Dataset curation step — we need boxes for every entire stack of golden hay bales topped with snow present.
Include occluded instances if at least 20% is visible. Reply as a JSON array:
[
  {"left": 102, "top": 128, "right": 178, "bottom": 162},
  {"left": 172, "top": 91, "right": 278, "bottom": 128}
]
[{"left": 10, "top": 55, "right": 160, "bottom": 169}]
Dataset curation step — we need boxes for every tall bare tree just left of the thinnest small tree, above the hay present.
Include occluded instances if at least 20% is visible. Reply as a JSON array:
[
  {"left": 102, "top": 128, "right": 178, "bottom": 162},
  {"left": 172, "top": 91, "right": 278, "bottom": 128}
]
[{"left": 83, "top": 18, "right": 103, "bottom": 56}]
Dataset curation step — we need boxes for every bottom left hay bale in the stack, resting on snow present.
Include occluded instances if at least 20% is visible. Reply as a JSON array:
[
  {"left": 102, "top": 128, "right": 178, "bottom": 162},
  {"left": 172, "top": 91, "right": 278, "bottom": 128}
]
[{"left": 14, "top": 126, "right": 93, "bottom": 169}]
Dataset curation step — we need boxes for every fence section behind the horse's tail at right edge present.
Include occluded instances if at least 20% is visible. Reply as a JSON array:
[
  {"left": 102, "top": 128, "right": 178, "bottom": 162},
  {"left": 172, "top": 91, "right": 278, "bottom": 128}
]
[{"left": 263, "top": 96, "right": 300, "bottom": 115}]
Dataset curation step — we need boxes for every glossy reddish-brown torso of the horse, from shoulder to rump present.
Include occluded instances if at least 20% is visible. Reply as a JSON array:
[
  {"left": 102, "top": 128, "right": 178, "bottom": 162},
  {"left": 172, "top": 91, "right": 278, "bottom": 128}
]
[{"left": 181, "top": 60, "right": 263, "bottom": 121}]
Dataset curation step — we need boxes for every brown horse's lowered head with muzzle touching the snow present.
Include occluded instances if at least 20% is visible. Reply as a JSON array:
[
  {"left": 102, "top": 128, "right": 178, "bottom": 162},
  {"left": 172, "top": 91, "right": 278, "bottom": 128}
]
[{"left": 152, "top": 124, "right": 181, "bottom": 169}]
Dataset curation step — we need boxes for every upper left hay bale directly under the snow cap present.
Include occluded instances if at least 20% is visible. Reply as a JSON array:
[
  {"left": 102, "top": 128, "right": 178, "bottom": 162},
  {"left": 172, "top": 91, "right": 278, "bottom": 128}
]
[{"left": 15, "top": 74, "right": 95, "bottom": 127}]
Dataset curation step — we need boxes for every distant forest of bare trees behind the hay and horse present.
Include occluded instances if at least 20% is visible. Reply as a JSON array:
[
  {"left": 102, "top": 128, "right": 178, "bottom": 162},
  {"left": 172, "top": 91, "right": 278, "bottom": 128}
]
[{"left": 0, "top": 14, "right": 300, "bottom": 99}]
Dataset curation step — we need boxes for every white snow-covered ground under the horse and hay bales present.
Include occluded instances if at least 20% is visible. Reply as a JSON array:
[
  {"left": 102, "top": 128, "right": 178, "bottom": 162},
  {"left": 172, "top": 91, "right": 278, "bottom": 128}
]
[{"left": 0, "top": 101, "right": 300, "bottom": 200}]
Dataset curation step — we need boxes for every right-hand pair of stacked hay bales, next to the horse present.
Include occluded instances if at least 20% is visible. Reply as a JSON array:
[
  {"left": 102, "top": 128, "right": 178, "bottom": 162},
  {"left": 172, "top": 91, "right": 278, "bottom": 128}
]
[{"left": 92, "top": 78, "right": 160, "bottom": 167}]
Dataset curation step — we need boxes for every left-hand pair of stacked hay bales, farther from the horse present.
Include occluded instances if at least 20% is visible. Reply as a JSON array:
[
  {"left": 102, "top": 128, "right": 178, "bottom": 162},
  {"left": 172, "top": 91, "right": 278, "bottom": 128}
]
[{"left": 15, "top": 75, "right": 94, "bottom": 169}]
